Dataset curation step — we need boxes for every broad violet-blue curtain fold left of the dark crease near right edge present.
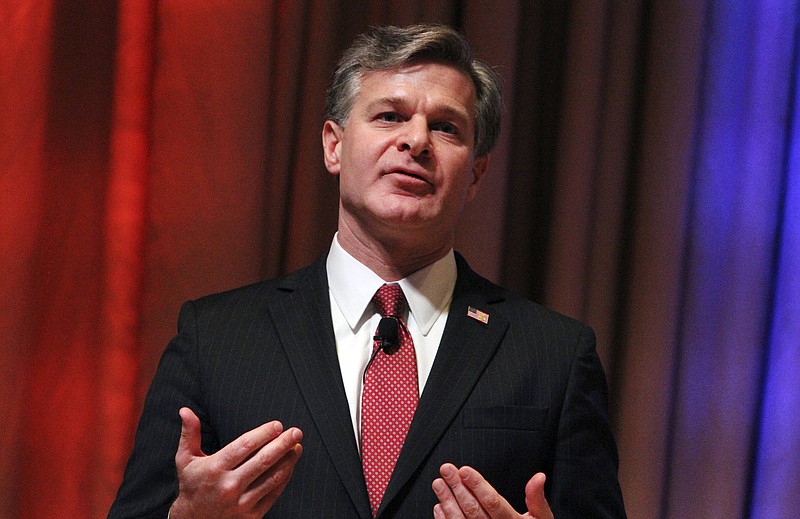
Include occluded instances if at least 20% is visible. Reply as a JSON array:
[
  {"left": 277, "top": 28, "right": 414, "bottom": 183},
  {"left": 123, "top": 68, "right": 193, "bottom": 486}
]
[{"left": 664, "top": 2, "right": 796, "bottom": 517}]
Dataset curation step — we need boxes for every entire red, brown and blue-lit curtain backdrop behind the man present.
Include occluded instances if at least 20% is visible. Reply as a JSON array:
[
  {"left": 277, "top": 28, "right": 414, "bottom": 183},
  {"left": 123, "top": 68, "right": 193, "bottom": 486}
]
[{"left": 0, "top": 0, "right": 800, "bottom": 519}]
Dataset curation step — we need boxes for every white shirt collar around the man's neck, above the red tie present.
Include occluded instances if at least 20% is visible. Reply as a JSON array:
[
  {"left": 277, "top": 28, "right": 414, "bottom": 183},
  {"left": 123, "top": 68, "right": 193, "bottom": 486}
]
[{"left": 326, "top": 233, "right": 456, "bottom": 335}]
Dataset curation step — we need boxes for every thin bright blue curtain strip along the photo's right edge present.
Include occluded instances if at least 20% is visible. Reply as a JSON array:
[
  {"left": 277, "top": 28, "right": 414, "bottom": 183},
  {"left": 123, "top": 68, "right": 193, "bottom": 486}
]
[{"left": 751, "top": 3, "right": 800, "bottom": 518}]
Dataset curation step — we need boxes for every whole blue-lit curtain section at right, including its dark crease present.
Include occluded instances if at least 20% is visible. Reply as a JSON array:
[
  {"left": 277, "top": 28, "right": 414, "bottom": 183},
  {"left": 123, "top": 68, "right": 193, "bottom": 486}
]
[{"left": 662, "top": 0, "right": 800, "bottom": 518}]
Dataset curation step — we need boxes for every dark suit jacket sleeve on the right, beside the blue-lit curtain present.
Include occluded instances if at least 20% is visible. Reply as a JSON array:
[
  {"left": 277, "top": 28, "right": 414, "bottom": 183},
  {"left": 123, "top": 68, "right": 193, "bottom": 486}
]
[{"left": 549, "top": 327, "right": 625, "bottom": 519}]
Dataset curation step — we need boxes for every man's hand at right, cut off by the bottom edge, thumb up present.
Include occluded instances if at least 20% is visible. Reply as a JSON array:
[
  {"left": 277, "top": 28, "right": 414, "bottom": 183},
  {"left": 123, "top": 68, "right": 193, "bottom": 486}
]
[{"left": 433, "top": 463, "right": 553, "bottom": 519}]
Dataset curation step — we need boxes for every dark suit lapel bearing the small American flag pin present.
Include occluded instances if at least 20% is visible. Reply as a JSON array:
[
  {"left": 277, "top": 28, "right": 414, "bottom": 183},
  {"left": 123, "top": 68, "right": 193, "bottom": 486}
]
[{"left": 379, "top": 255, "right": 508, "bottom": 514}]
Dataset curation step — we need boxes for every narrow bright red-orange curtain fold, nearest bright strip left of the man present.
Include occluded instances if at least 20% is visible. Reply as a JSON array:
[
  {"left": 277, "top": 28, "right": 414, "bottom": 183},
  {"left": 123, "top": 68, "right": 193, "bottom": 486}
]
[{"left": 97, "top": 0, "right": 155, "bottom": 516}]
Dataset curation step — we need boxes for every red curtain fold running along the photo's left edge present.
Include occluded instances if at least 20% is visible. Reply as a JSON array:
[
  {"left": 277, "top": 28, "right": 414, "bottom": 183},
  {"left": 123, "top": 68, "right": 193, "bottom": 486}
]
[{"left": 0, "top": 2, "right": 52, "bottom": 511}]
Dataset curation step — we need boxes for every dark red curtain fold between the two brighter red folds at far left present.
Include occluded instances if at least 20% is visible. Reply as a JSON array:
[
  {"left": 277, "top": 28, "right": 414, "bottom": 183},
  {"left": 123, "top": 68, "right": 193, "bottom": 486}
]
[{"left": 13, "top": 1, "right": 117, "bottom": 517}]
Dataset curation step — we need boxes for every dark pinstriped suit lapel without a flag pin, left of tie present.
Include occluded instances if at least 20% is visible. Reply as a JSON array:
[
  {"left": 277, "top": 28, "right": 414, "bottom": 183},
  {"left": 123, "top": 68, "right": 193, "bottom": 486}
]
[{"left": 269, "top": 256, "right": 371, "bottom": 518}]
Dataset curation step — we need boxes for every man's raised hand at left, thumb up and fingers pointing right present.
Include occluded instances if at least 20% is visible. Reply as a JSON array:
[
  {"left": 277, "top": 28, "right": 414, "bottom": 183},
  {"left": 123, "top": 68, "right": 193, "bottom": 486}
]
[{"left": 170, "top": 407, "right": 303, "bottom": 519}]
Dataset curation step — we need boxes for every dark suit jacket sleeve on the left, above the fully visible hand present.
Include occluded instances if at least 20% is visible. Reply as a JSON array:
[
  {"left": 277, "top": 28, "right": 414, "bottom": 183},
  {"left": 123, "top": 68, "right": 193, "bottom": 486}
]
[{"left": 108, "top": 302, "right": 218, "bottom": 519}]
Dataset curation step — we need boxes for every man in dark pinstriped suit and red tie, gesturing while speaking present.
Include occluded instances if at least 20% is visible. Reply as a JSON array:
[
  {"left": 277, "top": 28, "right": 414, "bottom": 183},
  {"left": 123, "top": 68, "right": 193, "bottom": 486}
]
[{"left": 109, "top": 26, "right": 625, "bottom": 519}]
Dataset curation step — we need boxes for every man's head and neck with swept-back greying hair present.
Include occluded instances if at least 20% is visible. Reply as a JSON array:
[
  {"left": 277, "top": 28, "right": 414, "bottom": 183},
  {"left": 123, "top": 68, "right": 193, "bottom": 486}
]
[{"left": 322, "top": 26, "right": 501, "bottom": 272}]
